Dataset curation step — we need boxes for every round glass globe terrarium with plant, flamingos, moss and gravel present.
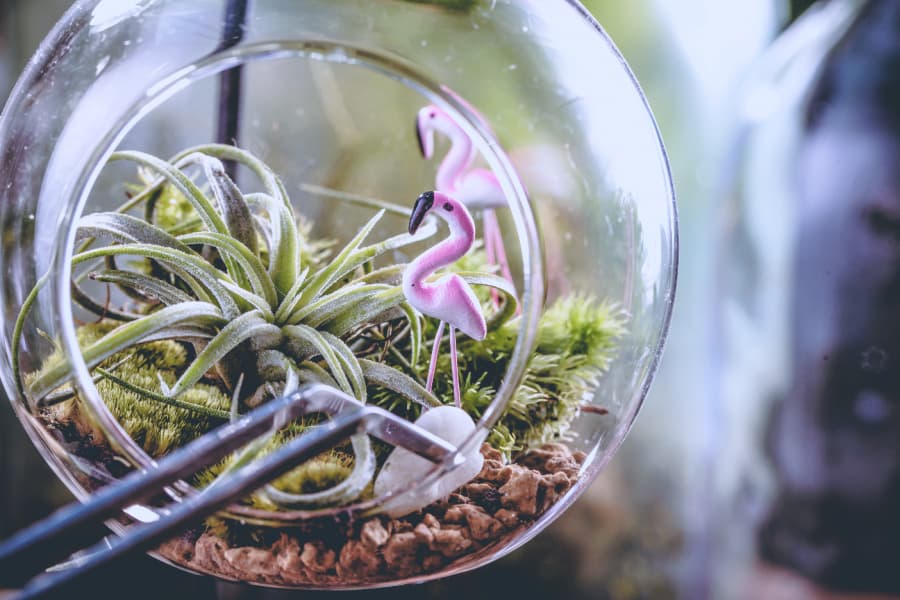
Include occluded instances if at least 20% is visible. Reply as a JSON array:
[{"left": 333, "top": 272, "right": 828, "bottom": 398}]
[{"left": 0, "top": 0, "right": 677, "bottom": 588}]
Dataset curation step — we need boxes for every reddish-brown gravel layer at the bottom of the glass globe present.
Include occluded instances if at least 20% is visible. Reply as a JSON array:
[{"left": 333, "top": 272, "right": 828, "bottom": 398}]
[{"left": 157, "top": 443, "right": 585, "bottom": 586}]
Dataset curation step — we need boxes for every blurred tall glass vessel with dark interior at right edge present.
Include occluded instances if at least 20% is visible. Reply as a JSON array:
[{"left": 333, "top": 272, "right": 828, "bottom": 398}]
[{"left": 716, "top": 0, "right": 900, "bottom": 596}]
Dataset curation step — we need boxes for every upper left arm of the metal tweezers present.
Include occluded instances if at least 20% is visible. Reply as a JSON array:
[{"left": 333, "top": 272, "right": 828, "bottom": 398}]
[{"left": 0, "top": 386, "right": 320, "bottom": 586}]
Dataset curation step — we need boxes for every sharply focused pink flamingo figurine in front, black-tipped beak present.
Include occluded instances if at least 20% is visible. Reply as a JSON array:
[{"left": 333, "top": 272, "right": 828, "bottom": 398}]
[{"left": 402, "top": 192, "right": 487, "bottom": 408}]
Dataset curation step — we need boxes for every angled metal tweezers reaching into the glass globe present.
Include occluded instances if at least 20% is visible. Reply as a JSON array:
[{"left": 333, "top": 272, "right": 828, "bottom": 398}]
[{"left": 0, "top": 384, "right": 460, "bottom": 598}]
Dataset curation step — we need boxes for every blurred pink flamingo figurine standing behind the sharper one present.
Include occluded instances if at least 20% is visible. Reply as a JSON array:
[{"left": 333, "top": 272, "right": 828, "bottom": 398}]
[{"left": 416, "top": 104, "right": 512, "bottom": 307}]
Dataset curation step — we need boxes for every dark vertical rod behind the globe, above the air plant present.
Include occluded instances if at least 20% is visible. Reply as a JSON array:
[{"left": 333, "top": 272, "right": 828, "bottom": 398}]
[{"left": 216, "top": 0, "right": 249, "bottom": 180}]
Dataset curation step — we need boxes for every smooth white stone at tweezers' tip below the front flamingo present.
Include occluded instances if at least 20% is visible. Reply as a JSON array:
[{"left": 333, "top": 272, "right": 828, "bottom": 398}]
[{"left": 375, "top": 406, "right": 484, "bottom": 517}]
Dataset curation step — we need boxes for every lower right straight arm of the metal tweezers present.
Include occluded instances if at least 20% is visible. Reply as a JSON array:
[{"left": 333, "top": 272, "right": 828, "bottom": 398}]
[{"left": 19, "top": 412, "right": 361, "bottom": 599}]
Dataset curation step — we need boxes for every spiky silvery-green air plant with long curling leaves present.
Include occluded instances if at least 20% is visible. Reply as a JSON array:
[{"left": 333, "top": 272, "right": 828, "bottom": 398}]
[{"left": 13, "top": 145, "right": 514, "bottom": 505}]
